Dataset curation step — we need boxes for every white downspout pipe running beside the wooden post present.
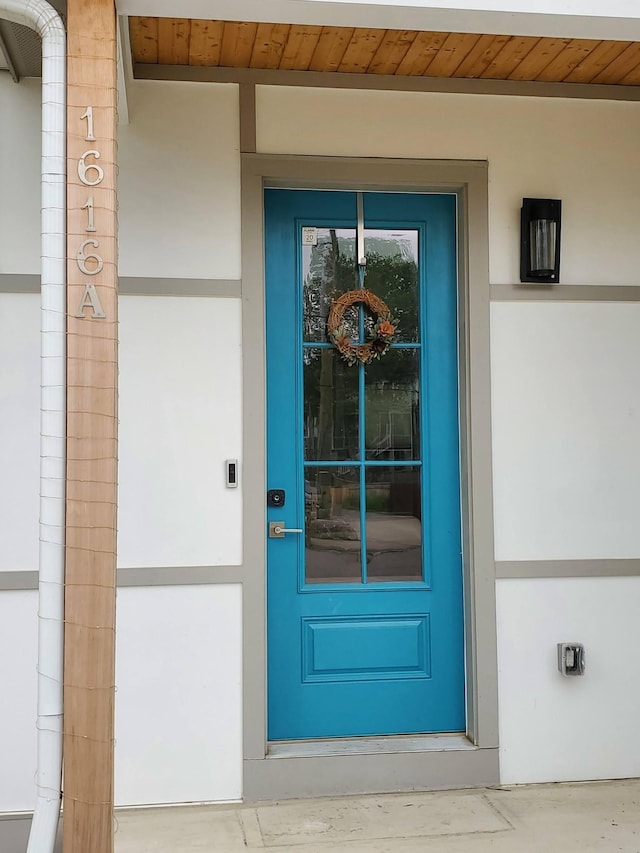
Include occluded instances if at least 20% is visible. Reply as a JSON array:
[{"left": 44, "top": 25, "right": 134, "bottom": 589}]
[{"left": 0, "top": 0, "right": 67, "bottom": 853}]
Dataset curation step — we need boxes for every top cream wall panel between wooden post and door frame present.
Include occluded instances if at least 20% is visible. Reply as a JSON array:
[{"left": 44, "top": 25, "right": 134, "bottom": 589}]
[{"left": 118, "top": 80, "right": 240, "bottom": 279}]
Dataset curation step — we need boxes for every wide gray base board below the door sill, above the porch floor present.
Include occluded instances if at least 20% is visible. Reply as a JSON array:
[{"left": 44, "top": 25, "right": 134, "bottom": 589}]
[{"left": 243, "top": 748, "right": 500, "bottom": 803}]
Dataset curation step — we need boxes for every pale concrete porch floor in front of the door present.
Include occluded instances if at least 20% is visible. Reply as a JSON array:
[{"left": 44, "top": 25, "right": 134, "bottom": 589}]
[{"left": 115, "top": 779, "right": 640, "bottom": 853}]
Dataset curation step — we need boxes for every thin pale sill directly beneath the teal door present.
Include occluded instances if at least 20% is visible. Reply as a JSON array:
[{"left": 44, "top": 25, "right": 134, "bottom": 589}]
[{"left": 267, "top": 733, "right": 478, "bottom": 758}]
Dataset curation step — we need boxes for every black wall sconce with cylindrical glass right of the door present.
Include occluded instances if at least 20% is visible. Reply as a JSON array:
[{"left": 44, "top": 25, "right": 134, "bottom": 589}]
[{"left": 520, "top": 198, "right": 562, "bottom": 284}]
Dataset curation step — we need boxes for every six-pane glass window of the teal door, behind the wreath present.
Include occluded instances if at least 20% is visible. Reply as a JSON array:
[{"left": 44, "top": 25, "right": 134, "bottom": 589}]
[{"left": 299, "top": 223, "right": 423, "bottom": 585}]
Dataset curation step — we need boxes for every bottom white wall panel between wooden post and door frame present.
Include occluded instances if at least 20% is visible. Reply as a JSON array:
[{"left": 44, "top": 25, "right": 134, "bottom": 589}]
[{"left": 115, "top": 584, "right": 242, "bottom": 805}]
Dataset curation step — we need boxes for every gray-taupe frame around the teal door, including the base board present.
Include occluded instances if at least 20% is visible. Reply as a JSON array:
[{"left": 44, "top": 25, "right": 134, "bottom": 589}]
[{"left": 241, "top": 154, "right": 499, "bottom": 801}]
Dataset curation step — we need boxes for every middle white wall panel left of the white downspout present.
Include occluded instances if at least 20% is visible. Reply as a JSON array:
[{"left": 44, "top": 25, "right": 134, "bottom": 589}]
[{"left": 0, "top": 292, "right": 40, "bottom": 572}]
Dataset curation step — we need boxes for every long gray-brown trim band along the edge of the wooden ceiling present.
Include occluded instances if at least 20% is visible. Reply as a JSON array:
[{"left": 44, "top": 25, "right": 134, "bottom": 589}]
[{"left": 133, "top": 62, "right": 640, "bottom": 101}]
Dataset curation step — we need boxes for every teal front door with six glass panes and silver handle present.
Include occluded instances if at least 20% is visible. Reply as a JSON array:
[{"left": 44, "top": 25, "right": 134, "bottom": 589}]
[{"left": 265, "top": 189, "right": 465, "bottom": 741}]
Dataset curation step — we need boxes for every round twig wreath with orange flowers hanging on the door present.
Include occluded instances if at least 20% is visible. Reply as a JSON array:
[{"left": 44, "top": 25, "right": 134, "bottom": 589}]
[{"left": 327, "top": 288, "right": 398, "bottom": 366}]
